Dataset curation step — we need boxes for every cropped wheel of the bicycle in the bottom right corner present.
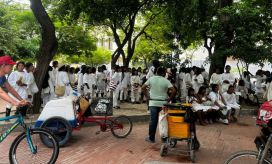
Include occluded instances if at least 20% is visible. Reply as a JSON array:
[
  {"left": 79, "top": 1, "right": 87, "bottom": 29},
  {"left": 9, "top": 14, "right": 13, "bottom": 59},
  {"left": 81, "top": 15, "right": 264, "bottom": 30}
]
[{"left": 224, "top": 151, "right": 272, "bottom": 164}]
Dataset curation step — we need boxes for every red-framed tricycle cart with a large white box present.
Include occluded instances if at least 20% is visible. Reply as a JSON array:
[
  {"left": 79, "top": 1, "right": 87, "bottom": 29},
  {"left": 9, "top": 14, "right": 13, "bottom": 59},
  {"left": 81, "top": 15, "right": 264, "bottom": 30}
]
[{"left": 35, "top": 97, "right": 133, "bottom": 146}]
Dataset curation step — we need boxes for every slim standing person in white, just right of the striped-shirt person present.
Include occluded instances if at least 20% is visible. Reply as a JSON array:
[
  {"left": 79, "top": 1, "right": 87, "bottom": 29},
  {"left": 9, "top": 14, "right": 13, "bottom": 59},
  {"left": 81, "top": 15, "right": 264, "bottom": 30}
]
[{"left": 120, "top": 67, "right": 129, "bottom": 102}]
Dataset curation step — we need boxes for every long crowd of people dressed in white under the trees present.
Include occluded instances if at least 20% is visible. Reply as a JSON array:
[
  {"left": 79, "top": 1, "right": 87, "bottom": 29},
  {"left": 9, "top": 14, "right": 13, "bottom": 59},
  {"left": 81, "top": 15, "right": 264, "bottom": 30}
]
[{"left": 0, "top": 56, "right": 272, "bottom": 125}]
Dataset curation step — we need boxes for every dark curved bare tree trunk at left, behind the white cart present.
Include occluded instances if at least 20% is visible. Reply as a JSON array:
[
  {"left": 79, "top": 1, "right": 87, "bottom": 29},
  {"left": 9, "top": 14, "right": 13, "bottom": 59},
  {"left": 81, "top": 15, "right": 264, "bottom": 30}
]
[{"left": 30, "top": 0, "right": 58, "bottom": 113}]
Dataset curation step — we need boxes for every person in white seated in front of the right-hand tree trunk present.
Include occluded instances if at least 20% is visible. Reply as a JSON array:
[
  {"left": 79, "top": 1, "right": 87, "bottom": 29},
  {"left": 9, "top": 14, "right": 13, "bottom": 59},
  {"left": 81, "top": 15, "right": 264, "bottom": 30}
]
[{"left": 208, "top": 84, "right": 230, "bottom": 124}]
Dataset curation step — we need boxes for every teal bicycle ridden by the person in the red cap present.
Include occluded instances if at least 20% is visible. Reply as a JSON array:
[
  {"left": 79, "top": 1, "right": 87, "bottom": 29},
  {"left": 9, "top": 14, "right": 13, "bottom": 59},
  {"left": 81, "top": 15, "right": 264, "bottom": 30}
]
[{"left": 0, "top": 107, "right": 59, "bottom": 164}]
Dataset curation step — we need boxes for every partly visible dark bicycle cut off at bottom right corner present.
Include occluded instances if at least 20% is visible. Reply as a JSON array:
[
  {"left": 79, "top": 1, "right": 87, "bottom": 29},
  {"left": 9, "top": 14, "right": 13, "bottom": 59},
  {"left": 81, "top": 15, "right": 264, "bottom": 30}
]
[{"left": 224, "top": 117, "right": 272, "bottom": 164}]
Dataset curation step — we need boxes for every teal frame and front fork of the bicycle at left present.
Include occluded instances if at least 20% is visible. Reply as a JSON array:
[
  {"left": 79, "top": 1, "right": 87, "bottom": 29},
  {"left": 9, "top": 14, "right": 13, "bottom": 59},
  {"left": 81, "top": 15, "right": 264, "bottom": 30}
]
[{"left": 0, "top": 114, "right": 37, "bottom": 154}]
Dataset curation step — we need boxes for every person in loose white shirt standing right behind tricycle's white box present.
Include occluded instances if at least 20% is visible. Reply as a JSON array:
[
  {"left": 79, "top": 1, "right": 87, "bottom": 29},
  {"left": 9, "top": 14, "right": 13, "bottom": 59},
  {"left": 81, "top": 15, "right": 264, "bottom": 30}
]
[{"left": 55, "top": 65, "right": 72, "bottom": 98}]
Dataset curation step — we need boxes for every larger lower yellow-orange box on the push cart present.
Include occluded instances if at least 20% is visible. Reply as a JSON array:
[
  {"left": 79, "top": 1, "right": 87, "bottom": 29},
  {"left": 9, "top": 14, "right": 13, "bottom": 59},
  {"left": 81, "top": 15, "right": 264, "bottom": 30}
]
[{"left": 168, "top": 121, "right": 190, "bottom": 139}]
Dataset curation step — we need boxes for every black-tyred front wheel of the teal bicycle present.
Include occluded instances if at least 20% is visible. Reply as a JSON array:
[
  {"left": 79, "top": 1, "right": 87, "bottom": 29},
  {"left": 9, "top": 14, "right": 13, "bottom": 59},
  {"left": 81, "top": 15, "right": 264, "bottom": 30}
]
[{"left": 9, "top": 128, "right": 59, "bottom": 164}]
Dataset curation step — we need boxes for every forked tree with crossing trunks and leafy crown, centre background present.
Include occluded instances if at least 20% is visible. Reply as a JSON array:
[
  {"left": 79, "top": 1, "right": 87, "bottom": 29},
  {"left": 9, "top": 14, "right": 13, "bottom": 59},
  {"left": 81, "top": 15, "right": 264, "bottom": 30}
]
[{"left": 56, "top": 0, "right": 163, "bottom": 66}]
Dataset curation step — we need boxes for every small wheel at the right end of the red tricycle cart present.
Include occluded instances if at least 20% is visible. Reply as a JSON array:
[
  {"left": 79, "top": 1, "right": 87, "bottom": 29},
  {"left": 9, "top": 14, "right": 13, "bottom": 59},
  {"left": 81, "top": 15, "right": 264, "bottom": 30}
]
[{"left": 111, "top": 116, "right": 133, "bottom": 138}]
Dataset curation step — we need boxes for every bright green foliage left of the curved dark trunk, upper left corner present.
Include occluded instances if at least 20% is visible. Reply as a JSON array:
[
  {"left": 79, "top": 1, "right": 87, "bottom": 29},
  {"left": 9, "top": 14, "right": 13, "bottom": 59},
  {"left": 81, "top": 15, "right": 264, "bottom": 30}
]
[{"left": 0, "top": 2, "right": 40, "bottom": 61}]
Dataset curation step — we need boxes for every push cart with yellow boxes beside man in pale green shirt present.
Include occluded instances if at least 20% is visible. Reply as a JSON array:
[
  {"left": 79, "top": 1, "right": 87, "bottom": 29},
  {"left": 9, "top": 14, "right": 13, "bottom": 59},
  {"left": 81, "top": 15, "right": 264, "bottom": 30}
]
[{"left": 160, "top": 104, "right": 199, "bottom": 162}]
